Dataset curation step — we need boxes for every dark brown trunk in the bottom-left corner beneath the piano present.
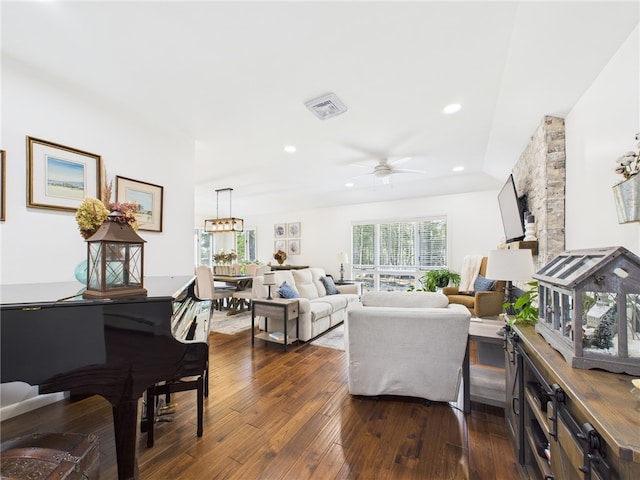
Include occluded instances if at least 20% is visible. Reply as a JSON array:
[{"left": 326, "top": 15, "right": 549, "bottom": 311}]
[{"left": 0, "top": 433, "right": 100, "bottom": 480}]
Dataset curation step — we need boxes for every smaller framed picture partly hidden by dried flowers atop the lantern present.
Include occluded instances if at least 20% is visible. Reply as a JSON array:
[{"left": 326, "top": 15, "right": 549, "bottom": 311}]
[{"left": 116, "top": 176, "right": 164, "bottom": 232}]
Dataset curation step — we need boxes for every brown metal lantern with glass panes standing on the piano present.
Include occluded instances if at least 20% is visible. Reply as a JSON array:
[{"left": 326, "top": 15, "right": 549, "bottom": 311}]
[{"left": 82, "top": 212, "right": 147, "bottom": 298}]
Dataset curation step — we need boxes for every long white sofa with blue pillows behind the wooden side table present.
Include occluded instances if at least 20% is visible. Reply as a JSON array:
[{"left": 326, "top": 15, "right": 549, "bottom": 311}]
[{"left": 251, "top": 267, "right": 359, "bottom": 342}]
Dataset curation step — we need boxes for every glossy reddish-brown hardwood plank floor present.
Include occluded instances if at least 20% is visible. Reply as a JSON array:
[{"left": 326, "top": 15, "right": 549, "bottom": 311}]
[{"left": 0, "top": 331, "right": 519, "bottom": 480}]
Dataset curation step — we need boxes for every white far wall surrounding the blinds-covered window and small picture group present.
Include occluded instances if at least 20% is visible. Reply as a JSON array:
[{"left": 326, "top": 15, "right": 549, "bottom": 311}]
[{"left": 245, "top": 190, "right": 504, "bottom": 277}]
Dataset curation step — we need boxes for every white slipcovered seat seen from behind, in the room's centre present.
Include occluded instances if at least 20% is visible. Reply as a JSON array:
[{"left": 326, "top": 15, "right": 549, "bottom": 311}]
[{"left": 345, "top": 292, "right": 471, "bottom": 402}]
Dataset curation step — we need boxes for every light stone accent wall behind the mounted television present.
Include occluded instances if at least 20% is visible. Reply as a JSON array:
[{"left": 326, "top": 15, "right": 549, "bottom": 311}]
[{"left": 513, "top": 116, "right": 566, "bottom": 269}]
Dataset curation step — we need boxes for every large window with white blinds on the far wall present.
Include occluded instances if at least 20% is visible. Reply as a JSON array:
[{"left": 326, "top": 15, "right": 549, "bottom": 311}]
[{"left": 351, "top": 217, "right": 447, "bottom": 290}]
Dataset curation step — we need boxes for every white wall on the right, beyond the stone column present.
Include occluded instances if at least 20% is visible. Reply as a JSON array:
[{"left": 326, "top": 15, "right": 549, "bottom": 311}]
[{"left": 565, "top": 27, "right": 640, "bottom": 254}]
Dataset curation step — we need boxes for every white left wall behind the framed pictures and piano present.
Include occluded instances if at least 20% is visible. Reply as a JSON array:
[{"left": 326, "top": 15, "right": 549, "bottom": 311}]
[{"left": 0, "top": 58, "right": 194, "bottom": 418}]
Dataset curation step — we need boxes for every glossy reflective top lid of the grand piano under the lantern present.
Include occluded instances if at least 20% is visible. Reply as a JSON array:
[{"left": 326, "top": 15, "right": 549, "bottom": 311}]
[{"left": 0, "top": 275, "right": 195, "bottom": 306}]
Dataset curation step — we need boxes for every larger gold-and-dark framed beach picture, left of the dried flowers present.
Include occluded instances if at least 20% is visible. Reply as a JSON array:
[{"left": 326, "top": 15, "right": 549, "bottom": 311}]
[{"left": 27, "top": 137, "right": 102, "bottom": 212}]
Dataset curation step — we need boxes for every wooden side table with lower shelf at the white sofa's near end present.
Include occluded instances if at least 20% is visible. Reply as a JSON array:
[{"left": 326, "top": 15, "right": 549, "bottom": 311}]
[{"left": 251, "top": 298, "right": 300, "bottom": 352}]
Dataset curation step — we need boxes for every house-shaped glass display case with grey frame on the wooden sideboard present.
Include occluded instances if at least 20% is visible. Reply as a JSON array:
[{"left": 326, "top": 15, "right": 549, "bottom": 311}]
[{"left": 533, "top": 247, "right": 640, "bottom": 375}]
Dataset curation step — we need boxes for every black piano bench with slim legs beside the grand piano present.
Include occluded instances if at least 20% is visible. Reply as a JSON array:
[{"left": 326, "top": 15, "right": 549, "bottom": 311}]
[{"left": 143, "top": 370, "right": 209, "bottom": 448}]
